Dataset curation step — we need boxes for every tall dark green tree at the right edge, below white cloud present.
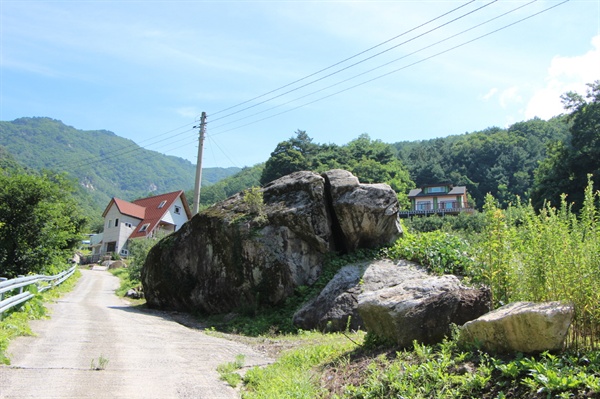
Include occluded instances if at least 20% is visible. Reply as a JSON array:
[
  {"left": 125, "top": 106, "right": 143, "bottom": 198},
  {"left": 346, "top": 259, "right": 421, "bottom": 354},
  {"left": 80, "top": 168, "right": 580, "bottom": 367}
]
[{"left": 531, "top": 80, "right": 600, "bottom": 210}]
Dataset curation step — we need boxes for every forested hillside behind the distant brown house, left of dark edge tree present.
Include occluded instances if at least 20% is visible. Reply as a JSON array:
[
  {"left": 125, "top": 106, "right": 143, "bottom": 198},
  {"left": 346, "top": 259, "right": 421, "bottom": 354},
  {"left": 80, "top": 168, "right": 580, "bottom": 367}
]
[{"left": 394, "top": 117, "right": 569, "bottom": 206}]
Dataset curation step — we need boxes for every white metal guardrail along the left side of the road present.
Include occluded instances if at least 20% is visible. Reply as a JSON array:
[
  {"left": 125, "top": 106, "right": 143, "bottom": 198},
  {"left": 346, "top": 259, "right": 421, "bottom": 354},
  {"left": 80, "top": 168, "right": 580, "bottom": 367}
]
[{"left": 0, "top": 266, "right": 76, "bottom": 319}]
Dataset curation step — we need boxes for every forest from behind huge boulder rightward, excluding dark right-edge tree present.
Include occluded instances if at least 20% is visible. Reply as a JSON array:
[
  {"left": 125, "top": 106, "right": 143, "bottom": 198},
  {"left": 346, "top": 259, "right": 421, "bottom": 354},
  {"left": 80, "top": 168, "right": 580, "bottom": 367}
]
[{"left": 255, "top": 117, "right": 570, "bottom": 208}]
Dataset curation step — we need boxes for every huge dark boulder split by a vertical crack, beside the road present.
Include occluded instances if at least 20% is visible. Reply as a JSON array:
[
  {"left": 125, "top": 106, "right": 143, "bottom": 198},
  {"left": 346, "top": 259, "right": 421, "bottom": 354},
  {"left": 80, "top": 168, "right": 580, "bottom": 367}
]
[{"left": 142, "top": 171, "right": 401, "bottom": 313}]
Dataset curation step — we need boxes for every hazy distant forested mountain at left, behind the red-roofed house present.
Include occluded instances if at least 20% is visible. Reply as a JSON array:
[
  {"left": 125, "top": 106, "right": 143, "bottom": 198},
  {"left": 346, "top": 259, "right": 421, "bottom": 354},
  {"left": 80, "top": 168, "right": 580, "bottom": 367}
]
[{"left": 0, "top": 117, "right": 239, "bottom": 227}]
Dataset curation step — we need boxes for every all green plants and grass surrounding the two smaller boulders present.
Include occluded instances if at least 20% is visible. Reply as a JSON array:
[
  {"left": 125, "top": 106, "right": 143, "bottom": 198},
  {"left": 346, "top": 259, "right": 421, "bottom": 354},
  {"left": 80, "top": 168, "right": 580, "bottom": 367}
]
[{"left": 209, "top": 179, "right": 600, "bottom": 399}]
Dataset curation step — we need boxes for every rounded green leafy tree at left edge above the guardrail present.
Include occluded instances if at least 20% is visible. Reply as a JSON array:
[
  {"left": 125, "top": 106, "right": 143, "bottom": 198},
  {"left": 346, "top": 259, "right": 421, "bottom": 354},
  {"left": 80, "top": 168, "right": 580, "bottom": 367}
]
[{"left": 0, "top": 169, "right": 86, "bottom": 277}]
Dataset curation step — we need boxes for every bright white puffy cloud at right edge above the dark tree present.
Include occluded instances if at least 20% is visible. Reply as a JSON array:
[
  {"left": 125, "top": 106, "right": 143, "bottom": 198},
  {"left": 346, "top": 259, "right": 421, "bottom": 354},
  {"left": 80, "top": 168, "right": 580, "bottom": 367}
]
[{"left": 525, "top": 35, "right": 600, "bottom": 119}]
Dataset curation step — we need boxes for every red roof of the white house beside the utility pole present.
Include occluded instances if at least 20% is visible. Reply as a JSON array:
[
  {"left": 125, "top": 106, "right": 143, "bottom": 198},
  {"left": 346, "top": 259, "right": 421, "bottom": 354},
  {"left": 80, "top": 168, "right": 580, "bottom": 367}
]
[{"left": 102, "top": 190, "right": 192, "bottom": 238}]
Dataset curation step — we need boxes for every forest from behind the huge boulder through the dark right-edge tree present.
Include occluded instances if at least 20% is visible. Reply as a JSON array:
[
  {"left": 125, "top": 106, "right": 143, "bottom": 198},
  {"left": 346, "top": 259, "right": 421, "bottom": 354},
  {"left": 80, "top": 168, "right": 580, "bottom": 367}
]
[{"left": 255, "top": 82, "right": 600, "bottom": 209}]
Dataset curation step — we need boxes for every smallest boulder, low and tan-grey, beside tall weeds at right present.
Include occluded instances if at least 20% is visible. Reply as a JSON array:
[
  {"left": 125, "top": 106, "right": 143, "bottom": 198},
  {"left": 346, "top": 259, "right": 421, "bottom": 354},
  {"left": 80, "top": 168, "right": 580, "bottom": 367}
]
[{"left": 460, "top": 302, "right": 574, "bottom": 353}]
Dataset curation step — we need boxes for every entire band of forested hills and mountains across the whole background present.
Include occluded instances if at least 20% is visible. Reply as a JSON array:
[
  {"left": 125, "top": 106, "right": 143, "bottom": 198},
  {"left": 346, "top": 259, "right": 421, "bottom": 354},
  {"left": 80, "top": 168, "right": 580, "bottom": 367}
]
[{"left": 0, "top": 82, "right": 600, "bottom": 228}]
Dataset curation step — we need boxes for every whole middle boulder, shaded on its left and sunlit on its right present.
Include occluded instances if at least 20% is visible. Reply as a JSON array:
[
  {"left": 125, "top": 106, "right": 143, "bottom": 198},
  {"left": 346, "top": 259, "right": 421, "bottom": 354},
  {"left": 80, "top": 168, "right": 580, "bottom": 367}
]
[{"left": 294, "top": 260, "right": 490, "bottom": 338}]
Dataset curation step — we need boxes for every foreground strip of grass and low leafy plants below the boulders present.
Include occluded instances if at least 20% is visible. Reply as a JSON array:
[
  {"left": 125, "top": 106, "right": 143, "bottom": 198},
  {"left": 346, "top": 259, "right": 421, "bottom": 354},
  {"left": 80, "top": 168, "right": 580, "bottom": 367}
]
[{"left": 233, "top": 332, "right": 600, "bottom": 399}]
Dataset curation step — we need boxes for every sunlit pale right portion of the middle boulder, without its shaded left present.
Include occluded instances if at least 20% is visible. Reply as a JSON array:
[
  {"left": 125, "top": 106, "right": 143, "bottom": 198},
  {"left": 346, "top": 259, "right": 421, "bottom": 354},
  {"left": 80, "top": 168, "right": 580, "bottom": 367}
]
[{"left": 358, "top": 264, "right": 491, "bottom": 347}]
